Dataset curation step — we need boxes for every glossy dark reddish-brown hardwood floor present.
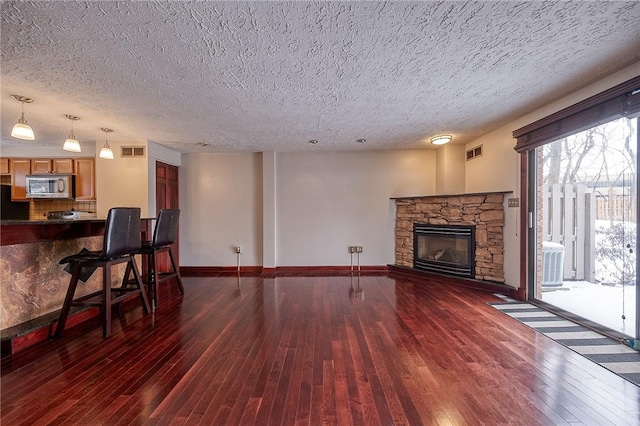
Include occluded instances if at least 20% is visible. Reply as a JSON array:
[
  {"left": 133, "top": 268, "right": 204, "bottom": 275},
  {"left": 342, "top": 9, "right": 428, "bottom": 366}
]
[{"left": 0, "top": 275, "right": 640, "bottom": 425}]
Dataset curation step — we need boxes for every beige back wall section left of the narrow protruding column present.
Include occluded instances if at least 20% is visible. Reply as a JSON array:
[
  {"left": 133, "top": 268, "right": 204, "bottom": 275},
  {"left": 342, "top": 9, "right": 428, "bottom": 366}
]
[{"left": 180, "top": 153, "right": 262, "bottom": 266}]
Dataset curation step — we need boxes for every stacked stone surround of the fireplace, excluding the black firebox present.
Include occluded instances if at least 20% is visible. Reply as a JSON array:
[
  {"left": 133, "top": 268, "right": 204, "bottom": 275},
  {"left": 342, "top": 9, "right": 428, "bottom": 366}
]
[{"left": 395, "top": 192, "right": 505, "bottom": 283}]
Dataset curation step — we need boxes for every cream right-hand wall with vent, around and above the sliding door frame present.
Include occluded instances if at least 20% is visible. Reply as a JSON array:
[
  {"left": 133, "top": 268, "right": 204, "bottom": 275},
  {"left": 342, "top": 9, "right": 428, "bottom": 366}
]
[{"left": 465, "top": 62, "right": 640, "bottom": 287}]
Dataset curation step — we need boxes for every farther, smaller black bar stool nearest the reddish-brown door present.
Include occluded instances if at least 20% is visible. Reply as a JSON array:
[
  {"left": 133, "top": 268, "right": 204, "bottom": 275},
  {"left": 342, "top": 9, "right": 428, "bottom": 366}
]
[{"left": 137, "top": 209, "right": 184, "bottom": 310}]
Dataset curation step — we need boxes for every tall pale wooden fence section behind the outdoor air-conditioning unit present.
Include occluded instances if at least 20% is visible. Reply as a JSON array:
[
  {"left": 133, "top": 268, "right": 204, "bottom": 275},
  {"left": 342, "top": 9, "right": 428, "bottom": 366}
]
[{"left": 542, "top": 184, "right": 596, "bottom": 282}]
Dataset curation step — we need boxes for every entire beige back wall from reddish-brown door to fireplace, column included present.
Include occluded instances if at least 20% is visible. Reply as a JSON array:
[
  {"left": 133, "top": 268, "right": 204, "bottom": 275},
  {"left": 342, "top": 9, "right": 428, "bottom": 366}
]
[{"left": 180, "top": 151, "right": 435, "bottom": 266}]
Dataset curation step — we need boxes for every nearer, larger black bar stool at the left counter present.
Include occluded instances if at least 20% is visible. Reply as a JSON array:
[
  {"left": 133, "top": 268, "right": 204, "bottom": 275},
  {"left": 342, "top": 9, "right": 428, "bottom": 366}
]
[{"left": 55, "top": 207, "right": 151, "bottom": 337}]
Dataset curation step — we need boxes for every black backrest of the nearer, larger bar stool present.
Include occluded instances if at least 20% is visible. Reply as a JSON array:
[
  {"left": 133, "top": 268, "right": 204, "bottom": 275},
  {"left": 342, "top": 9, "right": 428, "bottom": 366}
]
[{"left": 102, "top": 207, "right": 142, "bottom": 256}]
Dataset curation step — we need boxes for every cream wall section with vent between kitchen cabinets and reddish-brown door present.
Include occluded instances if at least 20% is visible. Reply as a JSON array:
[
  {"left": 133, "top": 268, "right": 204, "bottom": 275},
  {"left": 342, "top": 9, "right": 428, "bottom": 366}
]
[{"left": 96, "top": 141, "right": 149, "bottom": 218}]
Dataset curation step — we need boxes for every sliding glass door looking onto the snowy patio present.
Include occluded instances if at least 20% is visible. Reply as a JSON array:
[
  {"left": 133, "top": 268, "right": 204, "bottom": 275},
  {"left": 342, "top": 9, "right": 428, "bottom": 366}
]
[{"left": 529, "top": 118, "right": 638, "bottom": 338}]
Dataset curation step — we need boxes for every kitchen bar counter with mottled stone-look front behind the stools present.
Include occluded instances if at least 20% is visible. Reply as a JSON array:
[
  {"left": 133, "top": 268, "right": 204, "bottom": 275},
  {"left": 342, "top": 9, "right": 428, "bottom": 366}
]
[{"left": 0, "top": 219, "right": 153, "bottom": 355}]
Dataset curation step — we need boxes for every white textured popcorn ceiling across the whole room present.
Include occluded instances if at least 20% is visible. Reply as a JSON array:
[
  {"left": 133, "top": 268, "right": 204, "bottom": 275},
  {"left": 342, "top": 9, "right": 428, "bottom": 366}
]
[{"left": 0, "top": 1, "right": 640, "bottom": 152}]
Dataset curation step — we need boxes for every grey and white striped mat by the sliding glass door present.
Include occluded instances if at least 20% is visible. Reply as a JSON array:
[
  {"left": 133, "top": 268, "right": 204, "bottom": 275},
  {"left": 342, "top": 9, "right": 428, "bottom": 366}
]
[{"left": 489, "top": 296, "right": 640, "bottom": 386}]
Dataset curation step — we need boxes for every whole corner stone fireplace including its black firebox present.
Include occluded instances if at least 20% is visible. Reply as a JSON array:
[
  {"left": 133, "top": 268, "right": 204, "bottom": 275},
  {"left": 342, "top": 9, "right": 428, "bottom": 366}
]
[{"left": 395, "top": 192, "right": 507, "bottom": 283}]
